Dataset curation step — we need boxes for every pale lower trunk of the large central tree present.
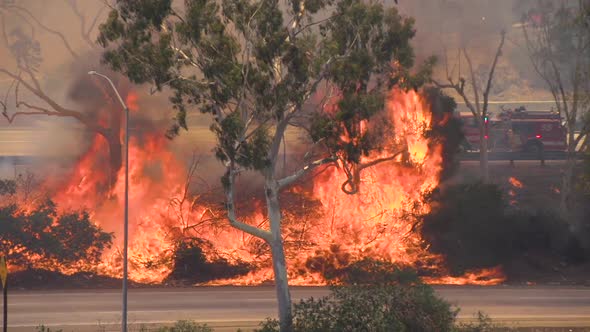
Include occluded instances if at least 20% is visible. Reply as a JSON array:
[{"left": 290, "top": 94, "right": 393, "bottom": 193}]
[{"left": 265, "top": 178, "right": 293, "bottom": 332}]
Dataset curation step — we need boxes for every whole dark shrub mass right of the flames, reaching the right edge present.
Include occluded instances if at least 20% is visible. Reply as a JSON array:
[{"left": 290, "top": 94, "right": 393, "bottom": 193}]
[{"left": 422, "top": 183, "right": 585, "bottom": 275}]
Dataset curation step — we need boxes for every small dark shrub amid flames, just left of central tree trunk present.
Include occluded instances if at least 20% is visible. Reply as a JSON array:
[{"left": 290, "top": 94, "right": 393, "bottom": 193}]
[{"left": 167, "top": 238, "right": 250, "bottom": 283}]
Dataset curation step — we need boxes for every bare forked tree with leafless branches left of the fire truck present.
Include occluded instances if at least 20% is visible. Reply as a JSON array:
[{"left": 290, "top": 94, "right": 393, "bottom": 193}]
[{"left": 433, "top": 31, "right": 505, "bottom": 182}]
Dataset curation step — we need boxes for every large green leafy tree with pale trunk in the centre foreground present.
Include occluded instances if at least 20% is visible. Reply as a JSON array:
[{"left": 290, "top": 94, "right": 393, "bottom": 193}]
[{"left": 99, "top": 0, "right": 433, "bottom": 331}]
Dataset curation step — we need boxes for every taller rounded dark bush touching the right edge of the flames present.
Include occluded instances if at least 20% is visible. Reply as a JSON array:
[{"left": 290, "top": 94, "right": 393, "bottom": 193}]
[{"left": 422, "top": 183, "right": 514, "bottom": 274}]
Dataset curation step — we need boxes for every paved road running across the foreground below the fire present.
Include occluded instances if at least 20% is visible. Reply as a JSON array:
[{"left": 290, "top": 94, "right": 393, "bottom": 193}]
[{"left": 3, "top": 286, "right": 590, "bottom": 331}]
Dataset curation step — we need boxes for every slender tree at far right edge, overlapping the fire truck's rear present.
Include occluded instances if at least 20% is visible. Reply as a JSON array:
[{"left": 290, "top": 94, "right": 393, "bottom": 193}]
[{"left": 522, "top": 0, "right": 590, "bottom": 228}]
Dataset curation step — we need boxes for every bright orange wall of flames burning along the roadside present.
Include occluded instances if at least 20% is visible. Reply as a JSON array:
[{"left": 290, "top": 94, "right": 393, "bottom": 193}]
[{"left": 2, "top": 83, "right": 503, "bottom": 285}]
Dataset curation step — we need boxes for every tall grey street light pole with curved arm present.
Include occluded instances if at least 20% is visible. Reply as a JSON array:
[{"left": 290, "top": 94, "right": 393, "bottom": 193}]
[{"left": 88, "top": 70, "right": 129, "bottom": 332}]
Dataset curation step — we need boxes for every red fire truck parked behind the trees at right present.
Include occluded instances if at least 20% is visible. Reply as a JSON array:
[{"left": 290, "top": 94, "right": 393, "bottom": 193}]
[{"left": 462, "top": 107, "right": 567, "bottom": 153}]
